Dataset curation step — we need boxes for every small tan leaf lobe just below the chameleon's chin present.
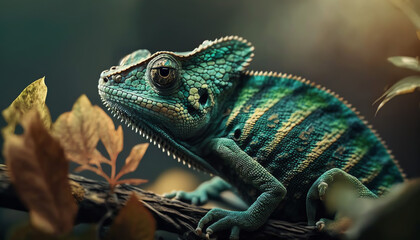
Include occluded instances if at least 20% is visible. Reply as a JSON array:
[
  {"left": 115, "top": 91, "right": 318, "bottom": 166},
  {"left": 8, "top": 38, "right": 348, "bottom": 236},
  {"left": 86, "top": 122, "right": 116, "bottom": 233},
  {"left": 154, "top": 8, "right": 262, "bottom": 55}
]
[{"left": 94, "top": 106, "right": 123, "bottom": 161}]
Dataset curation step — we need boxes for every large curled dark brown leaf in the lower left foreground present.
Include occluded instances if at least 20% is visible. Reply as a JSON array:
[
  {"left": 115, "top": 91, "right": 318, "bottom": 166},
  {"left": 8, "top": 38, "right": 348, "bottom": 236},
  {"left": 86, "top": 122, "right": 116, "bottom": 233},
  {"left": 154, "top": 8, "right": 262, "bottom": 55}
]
[{"left": 3, "top": 110, "right": 77, "bottom": 234}]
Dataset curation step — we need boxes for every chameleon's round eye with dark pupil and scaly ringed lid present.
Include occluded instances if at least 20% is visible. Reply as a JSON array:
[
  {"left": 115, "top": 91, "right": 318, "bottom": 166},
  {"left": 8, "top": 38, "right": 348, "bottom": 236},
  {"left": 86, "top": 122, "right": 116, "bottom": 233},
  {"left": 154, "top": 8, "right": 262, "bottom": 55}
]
[{"left": 147, "top": 54, "right": 180, "bottom": 92}]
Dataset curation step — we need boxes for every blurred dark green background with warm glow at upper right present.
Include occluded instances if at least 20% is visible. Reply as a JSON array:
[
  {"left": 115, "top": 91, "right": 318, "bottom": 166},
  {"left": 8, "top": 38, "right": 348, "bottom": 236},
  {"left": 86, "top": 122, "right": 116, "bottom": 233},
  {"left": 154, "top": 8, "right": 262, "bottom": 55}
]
[{"left": 0, "top": 0, "right": 420, "bottom": 236}]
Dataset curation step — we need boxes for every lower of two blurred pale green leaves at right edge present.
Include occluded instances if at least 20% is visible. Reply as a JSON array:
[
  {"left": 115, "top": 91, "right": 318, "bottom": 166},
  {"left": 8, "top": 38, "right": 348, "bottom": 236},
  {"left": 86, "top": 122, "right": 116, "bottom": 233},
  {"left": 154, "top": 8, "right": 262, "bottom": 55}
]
[{"left": 373, "top": 76, "right": 420, "bottom": 113}]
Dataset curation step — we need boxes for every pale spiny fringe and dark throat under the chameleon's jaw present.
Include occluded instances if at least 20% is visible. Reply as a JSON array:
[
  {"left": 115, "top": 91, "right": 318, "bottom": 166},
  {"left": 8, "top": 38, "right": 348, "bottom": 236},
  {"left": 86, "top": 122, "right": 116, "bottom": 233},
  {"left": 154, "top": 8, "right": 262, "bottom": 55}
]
[{"left": 98, "top": 85, "right": 217, "bottom": 175}]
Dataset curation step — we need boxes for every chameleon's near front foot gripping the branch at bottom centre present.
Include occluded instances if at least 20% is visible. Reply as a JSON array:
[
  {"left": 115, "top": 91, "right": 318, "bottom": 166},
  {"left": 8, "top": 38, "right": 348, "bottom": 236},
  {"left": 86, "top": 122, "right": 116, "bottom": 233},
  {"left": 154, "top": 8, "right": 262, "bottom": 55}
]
[{"left": 196, "top": 208, "right": 254, "bottom": 239}]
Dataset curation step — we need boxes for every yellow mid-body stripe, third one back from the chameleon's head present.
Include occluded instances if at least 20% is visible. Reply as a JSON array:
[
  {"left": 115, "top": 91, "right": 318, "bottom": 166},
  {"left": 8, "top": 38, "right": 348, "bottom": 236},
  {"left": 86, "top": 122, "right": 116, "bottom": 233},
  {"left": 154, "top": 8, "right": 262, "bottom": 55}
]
[{"left": 265, "top": 104, "right": 319, "bottom": 152}]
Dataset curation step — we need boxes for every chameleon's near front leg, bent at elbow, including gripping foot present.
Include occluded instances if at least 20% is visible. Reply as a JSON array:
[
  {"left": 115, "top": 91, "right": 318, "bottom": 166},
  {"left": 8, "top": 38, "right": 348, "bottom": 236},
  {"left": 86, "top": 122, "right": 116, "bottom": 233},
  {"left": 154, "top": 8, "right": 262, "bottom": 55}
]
[{"left": 196, "top": 138, "right": 286, "bottom": 239}]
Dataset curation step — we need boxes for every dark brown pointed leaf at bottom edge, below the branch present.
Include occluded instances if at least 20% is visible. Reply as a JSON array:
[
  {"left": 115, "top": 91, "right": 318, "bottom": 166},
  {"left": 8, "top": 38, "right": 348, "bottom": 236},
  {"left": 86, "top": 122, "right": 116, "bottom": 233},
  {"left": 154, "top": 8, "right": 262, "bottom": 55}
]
[{"left": 106, "top": 193, "right": 156, "bottom": 240}]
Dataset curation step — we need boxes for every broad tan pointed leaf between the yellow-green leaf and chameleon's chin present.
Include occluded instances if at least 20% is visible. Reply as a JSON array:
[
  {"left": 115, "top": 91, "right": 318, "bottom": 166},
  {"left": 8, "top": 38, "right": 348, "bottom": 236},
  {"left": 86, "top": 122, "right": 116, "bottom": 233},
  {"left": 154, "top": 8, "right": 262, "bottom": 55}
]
[{"left": 53, "top": 95, "right": 104, "bottom": 164}]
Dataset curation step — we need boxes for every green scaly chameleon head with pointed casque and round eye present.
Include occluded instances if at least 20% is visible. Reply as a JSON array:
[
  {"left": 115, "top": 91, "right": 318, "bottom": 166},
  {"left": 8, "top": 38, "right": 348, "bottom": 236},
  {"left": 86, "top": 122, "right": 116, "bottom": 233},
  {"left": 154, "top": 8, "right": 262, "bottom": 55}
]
[{"left": 98, "top": 37, "right": 253, "bottom": 172}]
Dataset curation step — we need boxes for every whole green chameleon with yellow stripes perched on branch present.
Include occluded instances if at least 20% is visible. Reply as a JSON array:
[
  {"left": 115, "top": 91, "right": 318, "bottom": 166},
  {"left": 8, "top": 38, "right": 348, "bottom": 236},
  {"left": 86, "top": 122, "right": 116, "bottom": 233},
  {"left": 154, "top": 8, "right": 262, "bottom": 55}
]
[{"left": 98, "top": 36, "right": 405, "bottom": 239}]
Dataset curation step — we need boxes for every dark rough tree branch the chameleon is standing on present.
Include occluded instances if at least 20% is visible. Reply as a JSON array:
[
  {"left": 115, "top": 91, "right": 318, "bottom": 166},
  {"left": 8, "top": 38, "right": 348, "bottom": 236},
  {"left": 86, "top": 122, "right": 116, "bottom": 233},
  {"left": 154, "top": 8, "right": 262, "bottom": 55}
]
[{"left": 0, "top": 164, "right": 331, "bottom": 240}]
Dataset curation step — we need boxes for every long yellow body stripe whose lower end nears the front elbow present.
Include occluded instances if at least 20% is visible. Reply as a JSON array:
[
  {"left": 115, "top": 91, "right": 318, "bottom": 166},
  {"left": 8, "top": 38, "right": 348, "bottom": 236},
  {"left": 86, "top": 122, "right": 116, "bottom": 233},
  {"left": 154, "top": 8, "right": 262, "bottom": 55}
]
[{"left": 284, "top": 125, "right": 346, "bottom": 184}]
